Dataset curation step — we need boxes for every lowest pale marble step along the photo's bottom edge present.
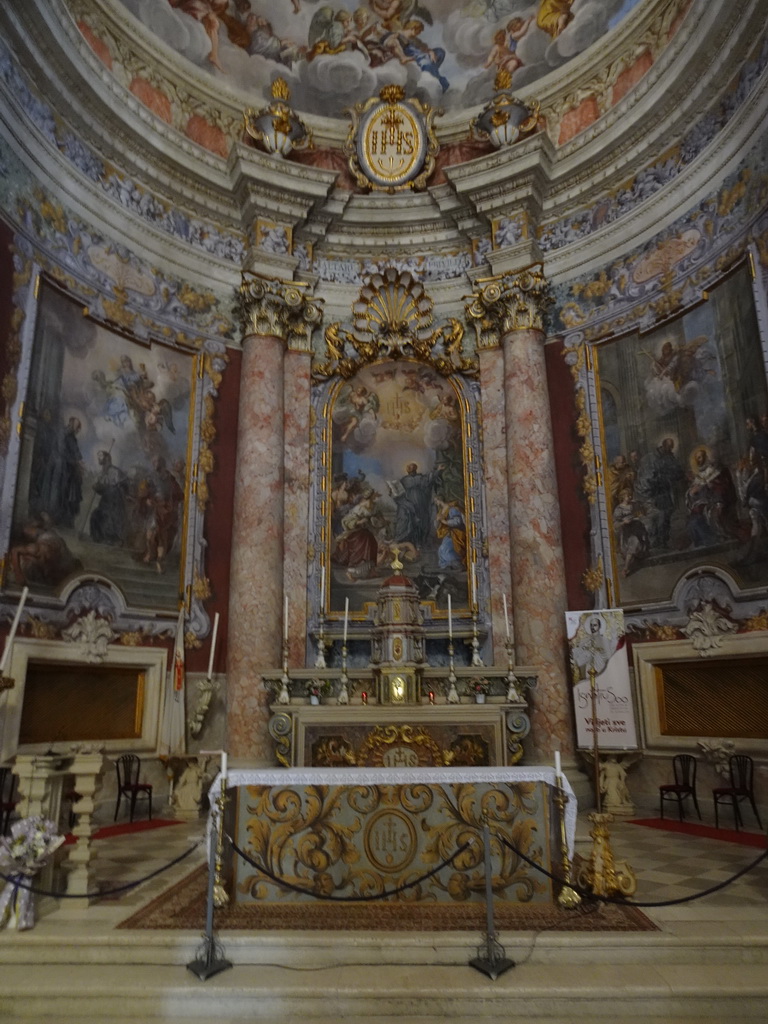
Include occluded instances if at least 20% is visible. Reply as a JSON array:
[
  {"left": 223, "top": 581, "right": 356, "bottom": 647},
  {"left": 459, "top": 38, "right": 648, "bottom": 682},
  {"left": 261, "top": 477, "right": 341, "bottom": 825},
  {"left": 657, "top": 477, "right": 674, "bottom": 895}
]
[{"left": 0, "top": 963, "right": 768, "bottom": 1024}]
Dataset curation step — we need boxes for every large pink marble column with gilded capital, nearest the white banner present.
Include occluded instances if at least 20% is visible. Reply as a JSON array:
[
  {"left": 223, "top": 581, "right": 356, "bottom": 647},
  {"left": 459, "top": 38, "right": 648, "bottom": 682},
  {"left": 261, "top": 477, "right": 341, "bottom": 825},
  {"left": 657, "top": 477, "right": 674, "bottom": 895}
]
[{"left": 470, "top": 267, "right": 573, "bottom": 762}]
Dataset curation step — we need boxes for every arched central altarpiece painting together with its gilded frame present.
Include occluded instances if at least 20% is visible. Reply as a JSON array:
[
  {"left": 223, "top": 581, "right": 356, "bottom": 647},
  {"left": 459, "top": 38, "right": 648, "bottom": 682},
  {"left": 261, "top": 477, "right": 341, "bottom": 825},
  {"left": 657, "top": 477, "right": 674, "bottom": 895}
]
[{"left": 310, "top": 358, "right": 486, "bottom": 629}]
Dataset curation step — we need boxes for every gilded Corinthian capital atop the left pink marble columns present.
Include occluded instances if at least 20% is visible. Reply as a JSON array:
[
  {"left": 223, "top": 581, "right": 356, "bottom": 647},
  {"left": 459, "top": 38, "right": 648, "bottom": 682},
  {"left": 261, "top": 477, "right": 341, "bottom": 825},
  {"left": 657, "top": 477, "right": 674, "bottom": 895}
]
[{"left": 238, "top": 274, "right": 323, "bottom": 352}]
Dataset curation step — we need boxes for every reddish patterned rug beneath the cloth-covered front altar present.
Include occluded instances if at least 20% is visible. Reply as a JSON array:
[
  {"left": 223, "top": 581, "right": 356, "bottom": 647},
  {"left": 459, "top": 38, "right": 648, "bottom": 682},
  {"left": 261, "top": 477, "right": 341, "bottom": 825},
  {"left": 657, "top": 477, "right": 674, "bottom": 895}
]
[{"left": 119, "top": 865, "right": 658, "bottom": 932}]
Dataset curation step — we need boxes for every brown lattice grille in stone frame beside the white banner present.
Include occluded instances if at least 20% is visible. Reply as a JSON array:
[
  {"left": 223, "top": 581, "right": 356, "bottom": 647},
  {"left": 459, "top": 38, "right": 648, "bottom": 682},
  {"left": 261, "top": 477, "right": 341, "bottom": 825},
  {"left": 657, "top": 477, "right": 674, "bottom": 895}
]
[{"left": 655, "top": 657, "right": 768, "bottom": 739}]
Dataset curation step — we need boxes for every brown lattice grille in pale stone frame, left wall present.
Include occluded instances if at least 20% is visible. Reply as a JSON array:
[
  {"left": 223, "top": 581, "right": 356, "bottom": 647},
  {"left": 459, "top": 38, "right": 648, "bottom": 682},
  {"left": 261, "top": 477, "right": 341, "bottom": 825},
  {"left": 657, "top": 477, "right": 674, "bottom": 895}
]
[{"left": 18, "top": 662, "right": 144, "bottom": 744}]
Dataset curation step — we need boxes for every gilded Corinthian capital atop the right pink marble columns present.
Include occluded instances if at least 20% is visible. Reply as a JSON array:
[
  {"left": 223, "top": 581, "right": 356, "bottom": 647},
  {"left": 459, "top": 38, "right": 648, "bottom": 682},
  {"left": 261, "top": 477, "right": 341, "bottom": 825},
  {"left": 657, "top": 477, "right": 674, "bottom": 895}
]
[{"left": 465, "top": 263, "right": 552, "bottom": 348}]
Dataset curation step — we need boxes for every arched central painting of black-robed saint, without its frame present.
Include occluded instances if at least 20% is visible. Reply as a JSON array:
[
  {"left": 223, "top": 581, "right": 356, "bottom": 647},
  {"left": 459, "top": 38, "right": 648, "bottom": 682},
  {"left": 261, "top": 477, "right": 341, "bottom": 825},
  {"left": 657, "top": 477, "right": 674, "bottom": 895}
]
[{"left": 327, "top": 359, "right": 468, "bottom": 613}]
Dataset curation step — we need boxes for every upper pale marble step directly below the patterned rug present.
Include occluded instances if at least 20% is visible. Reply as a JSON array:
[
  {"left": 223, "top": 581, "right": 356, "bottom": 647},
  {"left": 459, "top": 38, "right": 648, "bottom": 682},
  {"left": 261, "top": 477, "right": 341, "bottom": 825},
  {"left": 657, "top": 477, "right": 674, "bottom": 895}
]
[{"left": 0, "top": 925, "right": 768, "bottom": 977}]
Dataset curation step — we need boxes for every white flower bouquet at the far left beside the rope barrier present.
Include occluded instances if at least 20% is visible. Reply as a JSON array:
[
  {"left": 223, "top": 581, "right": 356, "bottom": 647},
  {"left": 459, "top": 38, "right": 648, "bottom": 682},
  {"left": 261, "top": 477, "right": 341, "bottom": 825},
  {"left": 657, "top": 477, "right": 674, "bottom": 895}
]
[{"left": 0, "top": 817, "right": 65, "bottom": 932}]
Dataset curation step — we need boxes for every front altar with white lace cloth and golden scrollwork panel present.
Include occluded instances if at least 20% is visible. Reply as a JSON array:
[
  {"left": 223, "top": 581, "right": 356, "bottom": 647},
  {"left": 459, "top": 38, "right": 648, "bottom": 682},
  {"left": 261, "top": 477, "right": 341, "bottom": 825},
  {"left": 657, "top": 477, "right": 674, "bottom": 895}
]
[{"left": 219, "top": 767, "right": 577, "bottom": 927}]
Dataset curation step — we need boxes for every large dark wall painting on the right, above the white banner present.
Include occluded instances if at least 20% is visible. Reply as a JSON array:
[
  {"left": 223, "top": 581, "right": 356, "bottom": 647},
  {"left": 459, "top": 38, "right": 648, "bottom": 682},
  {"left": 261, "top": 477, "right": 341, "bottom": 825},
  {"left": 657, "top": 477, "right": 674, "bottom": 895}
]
[{"left": 597, "top": 260, "right": 768, "bottom": 605}]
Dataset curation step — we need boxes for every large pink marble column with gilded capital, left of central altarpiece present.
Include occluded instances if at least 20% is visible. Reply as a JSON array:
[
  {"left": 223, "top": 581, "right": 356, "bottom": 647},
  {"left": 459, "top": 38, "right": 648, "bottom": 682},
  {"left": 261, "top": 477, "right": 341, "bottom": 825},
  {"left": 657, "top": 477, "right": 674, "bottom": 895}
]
[{"left": 225, "top": 278, "right": 322, "bottom": 766}]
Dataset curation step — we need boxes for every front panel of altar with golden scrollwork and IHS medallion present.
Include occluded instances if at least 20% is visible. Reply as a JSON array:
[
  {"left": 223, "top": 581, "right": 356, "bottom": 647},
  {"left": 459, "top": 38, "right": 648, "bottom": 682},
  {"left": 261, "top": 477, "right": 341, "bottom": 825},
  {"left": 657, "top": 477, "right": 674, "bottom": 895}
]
[{"left": 238, "top": 781, "right": 549, "bottom": 903}]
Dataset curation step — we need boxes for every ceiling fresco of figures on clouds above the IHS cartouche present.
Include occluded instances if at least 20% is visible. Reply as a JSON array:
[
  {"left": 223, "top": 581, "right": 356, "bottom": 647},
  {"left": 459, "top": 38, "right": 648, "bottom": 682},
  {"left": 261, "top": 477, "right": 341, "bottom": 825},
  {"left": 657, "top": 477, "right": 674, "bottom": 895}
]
[{"left": 114, "top": 0, "right": 641, "bottom": 117}]
